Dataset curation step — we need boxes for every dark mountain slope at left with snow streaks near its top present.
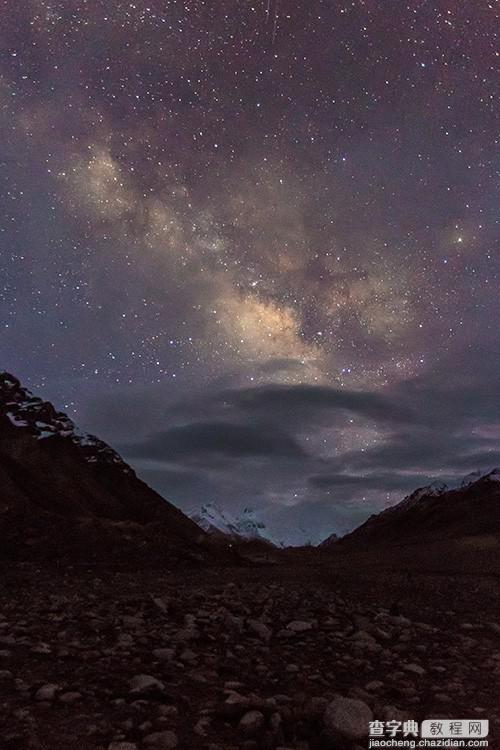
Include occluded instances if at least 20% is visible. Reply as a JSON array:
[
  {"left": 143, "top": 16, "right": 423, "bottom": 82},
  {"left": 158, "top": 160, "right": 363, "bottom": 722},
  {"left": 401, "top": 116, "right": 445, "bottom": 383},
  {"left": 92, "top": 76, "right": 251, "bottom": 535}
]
[{"left": 0, "top": 373, "right": 209, "bottom": 559}]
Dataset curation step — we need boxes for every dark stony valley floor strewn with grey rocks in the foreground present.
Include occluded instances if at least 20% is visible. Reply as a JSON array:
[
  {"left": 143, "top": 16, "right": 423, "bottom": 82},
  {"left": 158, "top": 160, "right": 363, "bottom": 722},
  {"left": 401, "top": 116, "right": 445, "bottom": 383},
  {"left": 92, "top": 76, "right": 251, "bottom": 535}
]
[{"left": 0, "top": 565, "right": 500, "bottom": 750}]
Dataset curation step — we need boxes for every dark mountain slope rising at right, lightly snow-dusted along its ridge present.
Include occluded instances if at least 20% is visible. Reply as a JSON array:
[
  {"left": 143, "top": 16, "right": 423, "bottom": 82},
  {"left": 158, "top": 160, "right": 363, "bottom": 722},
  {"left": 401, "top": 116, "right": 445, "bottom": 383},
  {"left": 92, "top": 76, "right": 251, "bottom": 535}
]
[{"left": 325, "top": 469, "right": 500, "bottom": 585}]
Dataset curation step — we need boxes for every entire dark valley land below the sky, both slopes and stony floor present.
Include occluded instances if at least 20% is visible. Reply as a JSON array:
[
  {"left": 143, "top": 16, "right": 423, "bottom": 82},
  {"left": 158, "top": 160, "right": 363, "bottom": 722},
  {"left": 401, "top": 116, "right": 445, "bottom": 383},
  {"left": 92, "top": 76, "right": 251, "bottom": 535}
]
[{"left": 0, "top": 373, "right": 500, "bottom": 750}]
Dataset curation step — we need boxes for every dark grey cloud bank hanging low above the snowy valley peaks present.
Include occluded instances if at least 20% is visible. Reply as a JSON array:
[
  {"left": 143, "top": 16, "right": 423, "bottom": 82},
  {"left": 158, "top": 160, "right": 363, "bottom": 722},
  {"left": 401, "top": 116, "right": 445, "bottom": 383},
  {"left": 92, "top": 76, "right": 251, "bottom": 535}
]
[{"left": 74, "top": 352, "right": 500, "bottom": 538}]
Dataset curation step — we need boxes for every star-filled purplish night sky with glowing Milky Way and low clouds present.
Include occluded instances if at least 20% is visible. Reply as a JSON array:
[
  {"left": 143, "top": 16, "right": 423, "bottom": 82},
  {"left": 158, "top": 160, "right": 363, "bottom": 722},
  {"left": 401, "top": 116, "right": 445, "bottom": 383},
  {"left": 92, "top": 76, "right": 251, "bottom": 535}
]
[{"left": 0, "top": 0, "right": 500, "bottom": 539}]
